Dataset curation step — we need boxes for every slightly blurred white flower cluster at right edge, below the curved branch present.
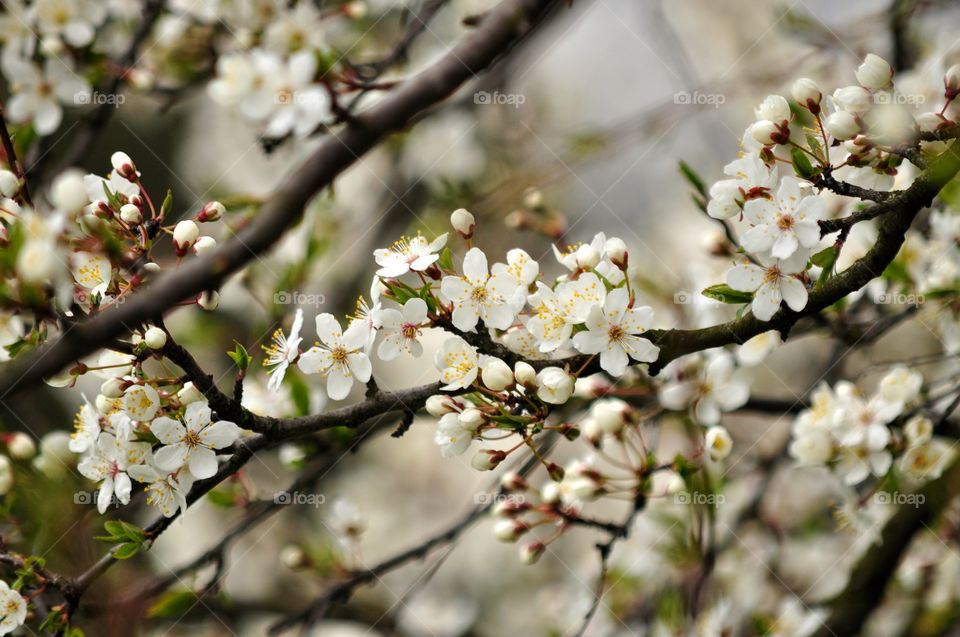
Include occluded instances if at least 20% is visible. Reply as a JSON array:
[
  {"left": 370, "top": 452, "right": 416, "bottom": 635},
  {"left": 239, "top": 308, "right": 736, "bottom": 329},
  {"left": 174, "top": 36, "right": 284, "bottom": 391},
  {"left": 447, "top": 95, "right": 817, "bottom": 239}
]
[{"left": 790, "top": 366, "right": 953, "bottom": 485}]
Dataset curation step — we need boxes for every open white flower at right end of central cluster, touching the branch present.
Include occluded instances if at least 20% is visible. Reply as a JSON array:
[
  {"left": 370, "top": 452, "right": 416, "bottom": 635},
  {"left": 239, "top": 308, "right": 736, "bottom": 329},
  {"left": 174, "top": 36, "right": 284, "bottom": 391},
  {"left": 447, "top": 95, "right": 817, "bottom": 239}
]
[{"left": 573, "top": 288, "right": 660, "bottom": 376}]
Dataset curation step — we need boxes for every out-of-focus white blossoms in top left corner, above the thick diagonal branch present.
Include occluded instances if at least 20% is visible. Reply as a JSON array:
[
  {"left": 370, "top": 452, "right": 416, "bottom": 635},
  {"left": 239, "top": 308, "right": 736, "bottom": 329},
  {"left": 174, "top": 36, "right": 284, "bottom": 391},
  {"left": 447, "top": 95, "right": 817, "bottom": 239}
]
[{"left": 0, "top": 0, "right": 366, "bottom": 138}]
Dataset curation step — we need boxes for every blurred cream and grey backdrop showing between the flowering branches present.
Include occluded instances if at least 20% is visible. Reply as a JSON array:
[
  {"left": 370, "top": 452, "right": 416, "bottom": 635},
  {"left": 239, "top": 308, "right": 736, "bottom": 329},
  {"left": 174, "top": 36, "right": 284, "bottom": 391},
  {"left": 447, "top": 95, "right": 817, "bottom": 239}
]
[{"left": 2, "top": 0, "right": 960, "bottom": 637}]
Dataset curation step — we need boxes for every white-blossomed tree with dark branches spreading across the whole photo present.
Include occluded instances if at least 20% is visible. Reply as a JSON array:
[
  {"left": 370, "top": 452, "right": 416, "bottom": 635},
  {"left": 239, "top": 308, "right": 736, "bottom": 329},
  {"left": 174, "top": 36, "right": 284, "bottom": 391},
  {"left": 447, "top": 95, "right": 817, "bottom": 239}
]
[{"left": 0, "top": 0, "right": 960, "bottom": 635}]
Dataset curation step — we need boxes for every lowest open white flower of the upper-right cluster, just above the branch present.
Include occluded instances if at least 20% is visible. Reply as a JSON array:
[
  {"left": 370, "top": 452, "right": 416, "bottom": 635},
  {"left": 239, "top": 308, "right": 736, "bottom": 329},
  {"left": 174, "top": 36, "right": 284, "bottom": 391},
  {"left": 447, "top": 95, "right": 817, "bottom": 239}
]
[{"left": 727, "top": 250, "right": 809, "bottom": 321}]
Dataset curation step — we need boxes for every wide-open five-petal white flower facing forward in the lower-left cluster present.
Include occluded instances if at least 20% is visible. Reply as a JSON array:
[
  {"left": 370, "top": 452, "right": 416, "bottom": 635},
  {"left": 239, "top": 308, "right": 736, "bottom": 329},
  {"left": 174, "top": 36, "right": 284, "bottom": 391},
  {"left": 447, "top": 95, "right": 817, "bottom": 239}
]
[{"left": 150, "top": 402, "right": 240, "bottom": 480}]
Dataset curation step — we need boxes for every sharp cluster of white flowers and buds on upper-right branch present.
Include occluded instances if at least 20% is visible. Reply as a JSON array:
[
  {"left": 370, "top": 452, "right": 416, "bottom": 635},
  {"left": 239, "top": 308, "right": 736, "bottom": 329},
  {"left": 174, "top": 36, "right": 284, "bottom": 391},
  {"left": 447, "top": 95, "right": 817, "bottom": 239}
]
[{"left": 707, "top": 54, "right": 960, "bottom": 320}]
